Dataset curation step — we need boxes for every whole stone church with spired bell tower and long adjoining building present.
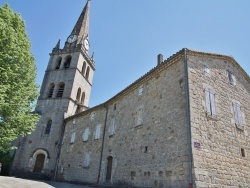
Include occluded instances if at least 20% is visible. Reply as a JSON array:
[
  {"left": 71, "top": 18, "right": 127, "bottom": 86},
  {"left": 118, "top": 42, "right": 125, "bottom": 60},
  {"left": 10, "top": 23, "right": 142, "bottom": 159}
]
[{"left": 11, "top": 0, "right": 250, "bottom": 188}]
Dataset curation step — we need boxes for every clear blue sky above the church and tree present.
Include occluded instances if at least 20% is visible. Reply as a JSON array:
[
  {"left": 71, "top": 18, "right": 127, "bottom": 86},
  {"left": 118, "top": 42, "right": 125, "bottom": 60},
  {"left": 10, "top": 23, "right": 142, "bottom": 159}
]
[{"left": 0, "top": 0, "right": 250, "bottom": 107}]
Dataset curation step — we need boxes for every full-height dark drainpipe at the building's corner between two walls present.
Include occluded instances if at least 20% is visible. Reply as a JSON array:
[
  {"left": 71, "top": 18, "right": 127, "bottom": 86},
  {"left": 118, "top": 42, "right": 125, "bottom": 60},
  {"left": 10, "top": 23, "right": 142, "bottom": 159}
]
[{"left": 184, "top": 48, "right": 193, "bottom": 188}]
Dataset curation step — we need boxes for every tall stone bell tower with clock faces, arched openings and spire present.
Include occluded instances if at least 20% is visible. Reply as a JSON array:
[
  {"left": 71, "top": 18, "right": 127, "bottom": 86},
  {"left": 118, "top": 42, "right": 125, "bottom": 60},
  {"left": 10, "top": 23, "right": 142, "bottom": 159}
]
[{"left": 11, "top": 0, "right": 95, "bottom": 178}]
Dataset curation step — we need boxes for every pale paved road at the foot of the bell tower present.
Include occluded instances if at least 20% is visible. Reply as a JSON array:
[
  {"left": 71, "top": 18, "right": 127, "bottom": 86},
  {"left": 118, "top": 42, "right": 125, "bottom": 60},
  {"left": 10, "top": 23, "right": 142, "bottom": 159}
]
[{"left": 0, "top": 176, "right": 92, "bottom": 188}]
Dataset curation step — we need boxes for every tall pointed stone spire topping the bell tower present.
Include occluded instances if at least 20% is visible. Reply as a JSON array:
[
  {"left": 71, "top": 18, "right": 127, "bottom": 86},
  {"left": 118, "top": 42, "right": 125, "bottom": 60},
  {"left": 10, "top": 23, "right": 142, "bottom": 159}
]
[{"left": 71, "top": 0, "right": 90, "bottom": 44}]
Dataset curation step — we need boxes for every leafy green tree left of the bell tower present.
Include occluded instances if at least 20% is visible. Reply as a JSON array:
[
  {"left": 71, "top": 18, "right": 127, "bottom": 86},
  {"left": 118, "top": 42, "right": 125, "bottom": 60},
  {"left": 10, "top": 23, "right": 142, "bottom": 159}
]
[{"left": 0, "top": 4, "right": 38, "bottom": 152}]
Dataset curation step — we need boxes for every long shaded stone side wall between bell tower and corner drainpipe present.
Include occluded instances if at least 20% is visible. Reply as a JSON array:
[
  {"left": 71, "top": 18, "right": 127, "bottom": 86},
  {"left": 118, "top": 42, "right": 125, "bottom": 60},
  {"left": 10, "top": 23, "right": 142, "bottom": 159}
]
[{"left": 57, "top": 57, "right": 188, "bottom": 188}]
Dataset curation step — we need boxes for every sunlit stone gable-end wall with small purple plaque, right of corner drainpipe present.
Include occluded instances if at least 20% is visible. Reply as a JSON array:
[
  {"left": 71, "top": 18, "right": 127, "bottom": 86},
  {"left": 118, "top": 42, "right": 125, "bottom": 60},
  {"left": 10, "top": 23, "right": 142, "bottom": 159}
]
[{"left": 188, "top": 52, "right": 250, "bottom": 188}]
